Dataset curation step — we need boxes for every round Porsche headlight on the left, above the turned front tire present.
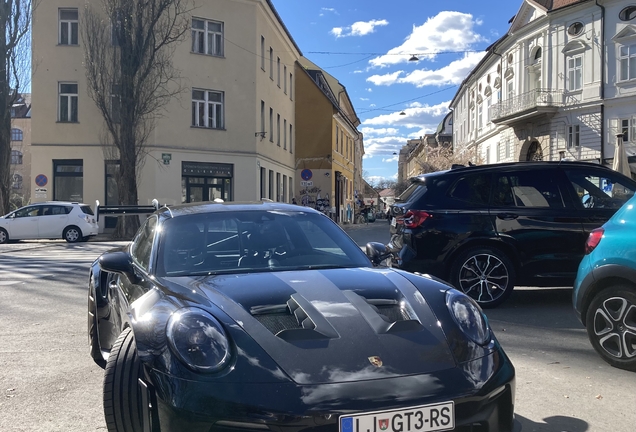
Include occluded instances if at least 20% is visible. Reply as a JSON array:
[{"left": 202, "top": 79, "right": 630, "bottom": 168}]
[{"left": 167, "top": 308, "right": 230, "bottom": 372}]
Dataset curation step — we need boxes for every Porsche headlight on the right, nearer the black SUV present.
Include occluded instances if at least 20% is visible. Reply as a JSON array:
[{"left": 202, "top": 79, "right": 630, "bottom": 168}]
[{"left": 446, "top": 289, "right": 490, "bottom": 345}]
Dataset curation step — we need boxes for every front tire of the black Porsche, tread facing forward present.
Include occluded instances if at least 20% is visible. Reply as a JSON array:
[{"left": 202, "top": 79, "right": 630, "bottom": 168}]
[{"left": 104, "top": 328, "right": 143, "bottom": 432}]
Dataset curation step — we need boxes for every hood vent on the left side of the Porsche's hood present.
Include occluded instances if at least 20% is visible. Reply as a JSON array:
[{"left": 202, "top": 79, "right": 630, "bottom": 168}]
[{"left": 250, "top": 294, "right": 340, "bottom": 342}]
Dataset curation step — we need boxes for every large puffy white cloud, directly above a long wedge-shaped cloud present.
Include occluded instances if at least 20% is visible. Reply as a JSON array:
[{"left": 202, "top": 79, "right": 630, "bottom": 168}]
[{"left": 369, "top": 11, "right": 485, "bottom": 67}]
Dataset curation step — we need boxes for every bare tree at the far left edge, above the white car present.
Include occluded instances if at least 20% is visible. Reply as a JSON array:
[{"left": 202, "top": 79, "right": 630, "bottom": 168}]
[{"left": 0, "top": 0, "right": 37, "bottom": 214}]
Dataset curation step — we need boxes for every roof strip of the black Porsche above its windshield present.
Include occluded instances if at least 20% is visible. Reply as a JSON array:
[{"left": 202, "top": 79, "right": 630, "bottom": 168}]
[{"left": 157, "top": 201, "right": 322, "bottom": 217}]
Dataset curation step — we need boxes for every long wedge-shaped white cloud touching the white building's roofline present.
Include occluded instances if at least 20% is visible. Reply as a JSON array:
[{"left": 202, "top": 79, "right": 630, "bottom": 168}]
[{"left": 367, "top": 52, "right": 486, "bottom": 87}]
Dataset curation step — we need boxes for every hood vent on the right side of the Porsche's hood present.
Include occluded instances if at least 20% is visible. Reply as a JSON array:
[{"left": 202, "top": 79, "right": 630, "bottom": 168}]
[{"left": 343, "top": 291, "right": 423, "bottom": 334}]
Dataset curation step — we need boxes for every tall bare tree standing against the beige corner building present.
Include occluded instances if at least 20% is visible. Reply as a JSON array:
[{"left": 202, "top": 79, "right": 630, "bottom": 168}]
[{"left": 79, "top": 0, "right": 192, "bottom": 238}]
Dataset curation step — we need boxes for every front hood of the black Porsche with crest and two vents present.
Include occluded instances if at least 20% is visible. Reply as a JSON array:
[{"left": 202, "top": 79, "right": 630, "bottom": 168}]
[{"left": 173, "top": 268, "right": 455, "bottom": 384}]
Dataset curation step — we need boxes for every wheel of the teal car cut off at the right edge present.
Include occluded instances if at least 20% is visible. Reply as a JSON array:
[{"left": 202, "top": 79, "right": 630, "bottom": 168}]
[{"left": 585, "top": 285, "right": 636, "bottom": 371}]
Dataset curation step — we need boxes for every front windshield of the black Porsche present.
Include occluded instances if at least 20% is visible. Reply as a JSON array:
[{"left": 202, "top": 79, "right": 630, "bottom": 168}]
[{"left": 157, "top": 210, "right": 371, "bottom": 276}]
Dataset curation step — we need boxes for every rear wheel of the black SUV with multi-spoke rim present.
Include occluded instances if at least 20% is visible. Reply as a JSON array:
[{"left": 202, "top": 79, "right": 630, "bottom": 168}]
[{"left": 451, "top": 248, "right": 515, "bottom": 309}]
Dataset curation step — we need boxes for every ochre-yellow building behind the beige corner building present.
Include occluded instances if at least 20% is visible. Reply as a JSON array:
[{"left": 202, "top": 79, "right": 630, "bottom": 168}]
[{"left": 296, "top": 58, "right": 364, "bottom": 223}]
